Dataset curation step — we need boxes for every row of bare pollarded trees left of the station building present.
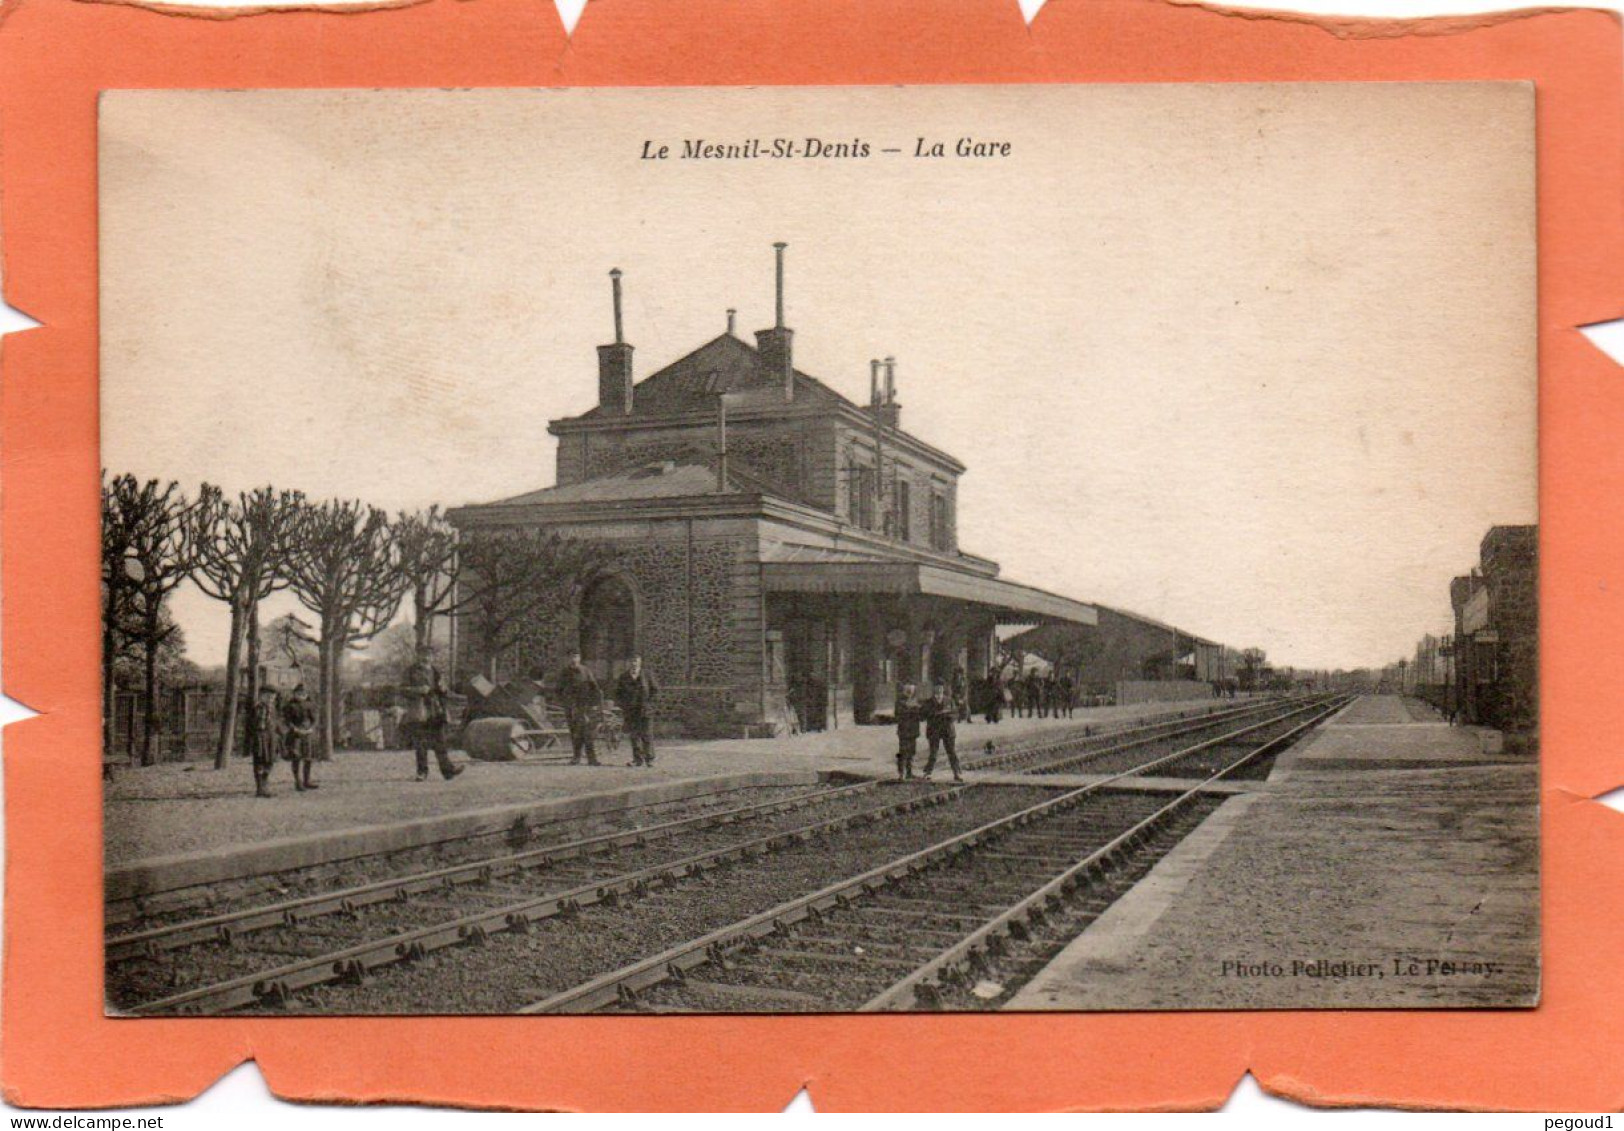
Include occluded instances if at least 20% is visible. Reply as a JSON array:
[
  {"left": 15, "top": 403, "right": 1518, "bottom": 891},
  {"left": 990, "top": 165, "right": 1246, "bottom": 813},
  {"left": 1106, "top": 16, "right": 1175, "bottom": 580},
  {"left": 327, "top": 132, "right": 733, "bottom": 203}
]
[{"left": 102, "top": 475, "right": 611, "bottom": 769}]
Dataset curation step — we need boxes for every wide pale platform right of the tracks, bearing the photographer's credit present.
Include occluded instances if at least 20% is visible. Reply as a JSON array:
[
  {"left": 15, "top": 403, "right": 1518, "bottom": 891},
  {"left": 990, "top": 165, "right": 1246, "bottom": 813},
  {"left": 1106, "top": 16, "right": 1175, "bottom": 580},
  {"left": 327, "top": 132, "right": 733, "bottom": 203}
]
[{"left": 1007, "top": 696, "right": 1540, "bottom": 1009}]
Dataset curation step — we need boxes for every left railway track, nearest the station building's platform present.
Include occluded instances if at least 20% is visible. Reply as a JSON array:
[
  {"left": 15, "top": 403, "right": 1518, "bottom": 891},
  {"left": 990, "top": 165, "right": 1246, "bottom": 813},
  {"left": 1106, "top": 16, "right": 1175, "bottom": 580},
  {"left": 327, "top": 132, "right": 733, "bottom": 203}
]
[{"left": 117, "top": 782, "right": 987, "bottom": 1016}]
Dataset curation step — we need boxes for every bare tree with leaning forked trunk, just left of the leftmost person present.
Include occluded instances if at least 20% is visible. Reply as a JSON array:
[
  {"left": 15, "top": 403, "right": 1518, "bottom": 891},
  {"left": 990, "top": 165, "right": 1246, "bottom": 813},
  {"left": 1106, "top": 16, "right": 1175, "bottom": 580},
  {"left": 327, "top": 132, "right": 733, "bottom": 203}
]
[{"left": 192, "top": 483, "right": 304, "bottom": 770}]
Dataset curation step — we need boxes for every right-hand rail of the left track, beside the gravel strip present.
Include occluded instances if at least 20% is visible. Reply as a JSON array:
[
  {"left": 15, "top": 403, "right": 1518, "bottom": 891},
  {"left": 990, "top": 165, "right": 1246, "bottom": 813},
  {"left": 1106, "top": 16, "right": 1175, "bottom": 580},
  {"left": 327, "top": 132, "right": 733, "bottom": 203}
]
[{"left": 123, "top": 788, "right": 965, "bottom": 1017}]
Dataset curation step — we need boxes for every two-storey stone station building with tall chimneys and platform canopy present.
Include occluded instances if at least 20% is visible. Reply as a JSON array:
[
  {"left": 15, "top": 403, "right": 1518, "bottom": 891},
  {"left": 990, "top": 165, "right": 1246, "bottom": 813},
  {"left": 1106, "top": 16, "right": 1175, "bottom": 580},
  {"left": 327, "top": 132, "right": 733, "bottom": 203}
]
[{"left": 450, "top": 245, "right": 1098, "bottom": 736}]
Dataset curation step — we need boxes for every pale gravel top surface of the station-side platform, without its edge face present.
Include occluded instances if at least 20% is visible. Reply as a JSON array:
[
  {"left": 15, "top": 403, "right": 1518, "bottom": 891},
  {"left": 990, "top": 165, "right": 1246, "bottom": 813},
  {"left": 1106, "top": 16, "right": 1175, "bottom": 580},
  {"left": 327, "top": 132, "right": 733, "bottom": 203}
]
[{"left": 102, "top": 704, "right": 1221, "bottom": 865}]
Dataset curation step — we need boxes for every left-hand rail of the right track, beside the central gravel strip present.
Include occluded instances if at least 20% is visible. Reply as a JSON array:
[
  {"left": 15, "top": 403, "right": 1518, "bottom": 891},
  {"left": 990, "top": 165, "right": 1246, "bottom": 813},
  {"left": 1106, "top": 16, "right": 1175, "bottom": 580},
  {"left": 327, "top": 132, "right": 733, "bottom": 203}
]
[{"left": 518, "top": 692, "right": 1344, "bottom": 1014}]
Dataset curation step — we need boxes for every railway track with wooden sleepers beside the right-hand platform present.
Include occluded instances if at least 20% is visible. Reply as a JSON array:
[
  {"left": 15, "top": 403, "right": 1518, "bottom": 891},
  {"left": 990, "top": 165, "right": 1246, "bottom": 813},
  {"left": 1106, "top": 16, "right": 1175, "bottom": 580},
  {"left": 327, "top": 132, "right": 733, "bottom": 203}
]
[{"left": 520, "top": 699, "right": 1345, "bottom": 1012}]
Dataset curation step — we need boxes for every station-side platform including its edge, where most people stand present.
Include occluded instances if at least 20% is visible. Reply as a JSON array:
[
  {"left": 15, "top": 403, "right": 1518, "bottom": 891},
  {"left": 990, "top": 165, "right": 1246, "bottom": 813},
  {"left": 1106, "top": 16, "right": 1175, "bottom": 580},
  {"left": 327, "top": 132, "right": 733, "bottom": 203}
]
[{"left": 102, "top": 700, "right": 1229, "bottom": 892}]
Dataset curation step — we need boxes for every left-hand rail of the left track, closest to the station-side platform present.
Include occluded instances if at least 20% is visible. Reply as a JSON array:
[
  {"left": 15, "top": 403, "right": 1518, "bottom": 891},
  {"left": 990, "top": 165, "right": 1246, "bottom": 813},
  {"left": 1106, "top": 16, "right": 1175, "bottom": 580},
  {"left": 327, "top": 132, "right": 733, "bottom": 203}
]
[{"left": 104, "top": 782, "right": 877, "bottom": 964}]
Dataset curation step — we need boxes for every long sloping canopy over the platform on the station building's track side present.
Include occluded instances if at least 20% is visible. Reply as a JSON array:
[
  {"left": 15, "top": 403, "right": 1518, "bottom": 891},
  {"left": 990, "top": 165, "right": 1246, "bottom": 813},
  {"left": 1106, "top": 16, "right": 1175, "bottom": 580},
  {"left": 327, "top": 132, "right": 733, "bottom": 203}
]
[{"left": 762, "top": 561, "right": 1099, "bottom": 624}]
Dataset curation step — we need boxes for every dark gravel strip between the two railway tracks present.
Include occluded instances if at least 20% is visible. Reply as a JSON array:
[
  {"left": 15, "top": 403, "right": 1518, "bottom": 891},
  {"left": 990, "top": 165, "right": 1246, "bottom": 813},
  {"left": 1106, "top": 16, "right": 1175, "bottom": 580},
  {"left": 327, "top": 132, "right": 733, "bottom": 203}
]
[{"left": 259, "top": 787, "right": 1052, "bottom": 1014}]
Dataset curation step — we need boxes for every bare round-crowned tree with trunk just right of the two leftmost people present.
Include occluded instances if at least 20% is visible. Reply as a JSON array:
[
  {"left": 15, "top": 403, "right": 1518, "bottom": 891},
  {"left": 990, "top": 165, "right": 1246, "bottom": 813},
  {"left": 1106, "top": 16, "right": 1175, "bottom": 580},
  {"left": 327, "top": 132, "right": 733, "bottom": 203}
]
[{"left": 286, "top": 501, "right": 406, "bottom": 759}]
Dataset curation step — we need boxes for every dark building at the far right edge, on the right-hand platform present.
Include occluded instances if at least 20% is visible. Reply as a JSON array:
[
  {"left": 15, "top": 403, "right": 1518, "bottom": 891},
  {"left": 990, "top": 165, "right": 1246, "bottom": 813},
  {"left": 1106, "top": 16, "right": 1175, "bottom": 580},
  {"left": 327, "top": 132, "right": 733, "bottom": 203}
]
[{"left": 1449, "top": 527, "right": 1540, "bottom": 731}]
